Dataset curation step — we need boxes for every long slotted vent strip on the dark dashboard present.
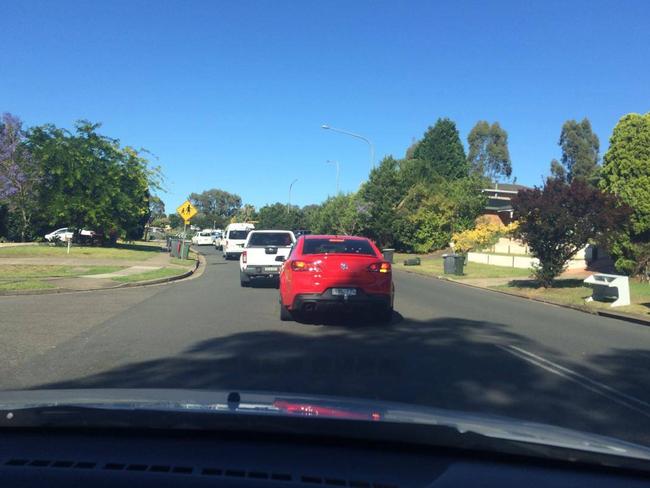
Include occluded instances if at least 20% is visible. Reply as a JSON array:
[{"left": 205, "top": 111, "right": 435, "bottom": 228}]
[{"left": 3, "top": 458, "right": 399, "bottom": 488}]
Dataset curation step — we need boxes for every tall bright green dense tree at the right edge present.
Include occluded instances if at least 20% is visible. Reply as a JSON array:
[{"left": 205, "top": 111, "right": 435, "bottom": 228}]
[{"left": 600, "top": 112, "right": 650, "bottom": 278}]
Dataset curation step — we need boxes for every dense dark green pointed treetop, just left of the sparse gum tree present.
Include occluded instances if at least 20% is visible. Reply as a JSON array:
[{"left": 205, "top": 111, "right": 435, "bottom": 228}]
[{"left": 413, "top": 118, "right": 469, "bottom": 179}]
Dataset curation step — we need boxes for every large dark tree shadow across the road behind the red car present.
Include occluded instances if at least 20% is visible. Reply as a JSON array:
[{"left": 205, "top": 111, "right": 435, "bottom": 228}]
[{"left": 38, "top": 317, "right": 650, "bottom": 445}]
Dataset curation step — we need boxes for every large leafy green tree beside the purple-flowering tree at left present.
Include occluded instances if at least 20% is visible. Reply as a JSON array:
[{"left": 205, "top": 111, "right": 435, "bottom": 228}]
[{"left": 28, "top": 121, "right": 160, "bottom": 239}]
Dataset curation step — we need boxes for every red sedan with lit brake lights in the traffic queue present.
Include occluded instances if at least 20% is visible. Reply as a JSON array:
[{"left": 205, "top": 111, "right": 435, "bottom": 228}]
[{"left": 280, "top": 235, "right": 395, "bottom": 322}]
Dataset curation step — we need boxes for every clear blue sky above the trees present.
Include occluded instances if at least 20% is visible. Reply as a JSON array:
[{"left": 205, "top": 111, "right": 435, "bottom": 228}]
[{"left": 0, "top": 0, "right": 650, "bottom": 212}]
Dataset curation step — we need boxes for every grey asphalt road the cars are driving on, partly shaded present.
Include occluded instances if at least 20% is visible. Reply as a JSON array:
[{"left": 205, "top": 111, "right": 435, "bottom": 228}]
[{"left": 0, "top": 247, "right": 650, "bottom": 446}]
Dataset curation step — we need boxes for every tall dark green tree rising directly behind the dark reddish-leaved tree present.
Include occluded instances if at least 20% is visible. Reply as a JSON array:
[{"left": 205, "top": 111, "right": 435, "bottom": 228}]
[{"left": 551, "top": 117, "right": 600, "bottom": 183}]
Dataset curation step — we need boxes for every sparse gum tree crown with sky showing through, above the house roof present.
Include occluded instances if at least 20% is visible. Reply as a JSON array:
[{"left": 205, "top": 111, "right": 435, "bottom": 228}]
[{"left": 467, "top": 120, "right": 512, "bottom": 181}]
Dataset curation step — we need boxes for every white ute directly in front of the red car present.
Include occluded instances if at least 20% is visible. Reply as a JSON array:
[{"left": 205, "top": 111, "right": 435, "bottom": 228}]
[{"left": 239, "top": 230, "right": 296, "bottom": 287}]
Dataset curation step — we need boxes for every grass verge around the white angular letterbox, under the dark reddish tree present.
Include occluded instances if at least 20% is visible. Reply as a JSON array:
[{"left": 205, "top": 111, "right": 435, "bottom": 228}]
[{"left": 494, "top": 279, "right": 650, "bottom": 317}]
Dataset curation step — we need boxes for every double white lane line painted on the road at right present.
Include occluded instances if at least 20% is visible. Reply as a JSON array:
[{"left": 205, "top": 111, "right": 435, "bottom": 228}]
[{"left": 497, "top": 345, "right": 650, "bottom": 418}]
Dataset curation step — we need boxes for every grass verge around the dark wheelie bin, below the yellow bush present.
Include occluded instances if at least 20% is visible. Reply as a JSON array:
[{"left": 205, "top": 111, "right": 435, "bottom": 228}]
[{"left": 393, "top": 253, "right": 530, "bottom": 280}]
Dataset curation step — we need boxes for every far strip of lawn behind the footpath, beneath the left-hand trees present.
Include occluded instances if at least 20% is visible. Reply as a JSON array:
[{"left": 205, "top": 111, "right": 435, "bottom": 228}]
[{"left": 0, "top": 243, "right": 160, "bottom": 261}]
